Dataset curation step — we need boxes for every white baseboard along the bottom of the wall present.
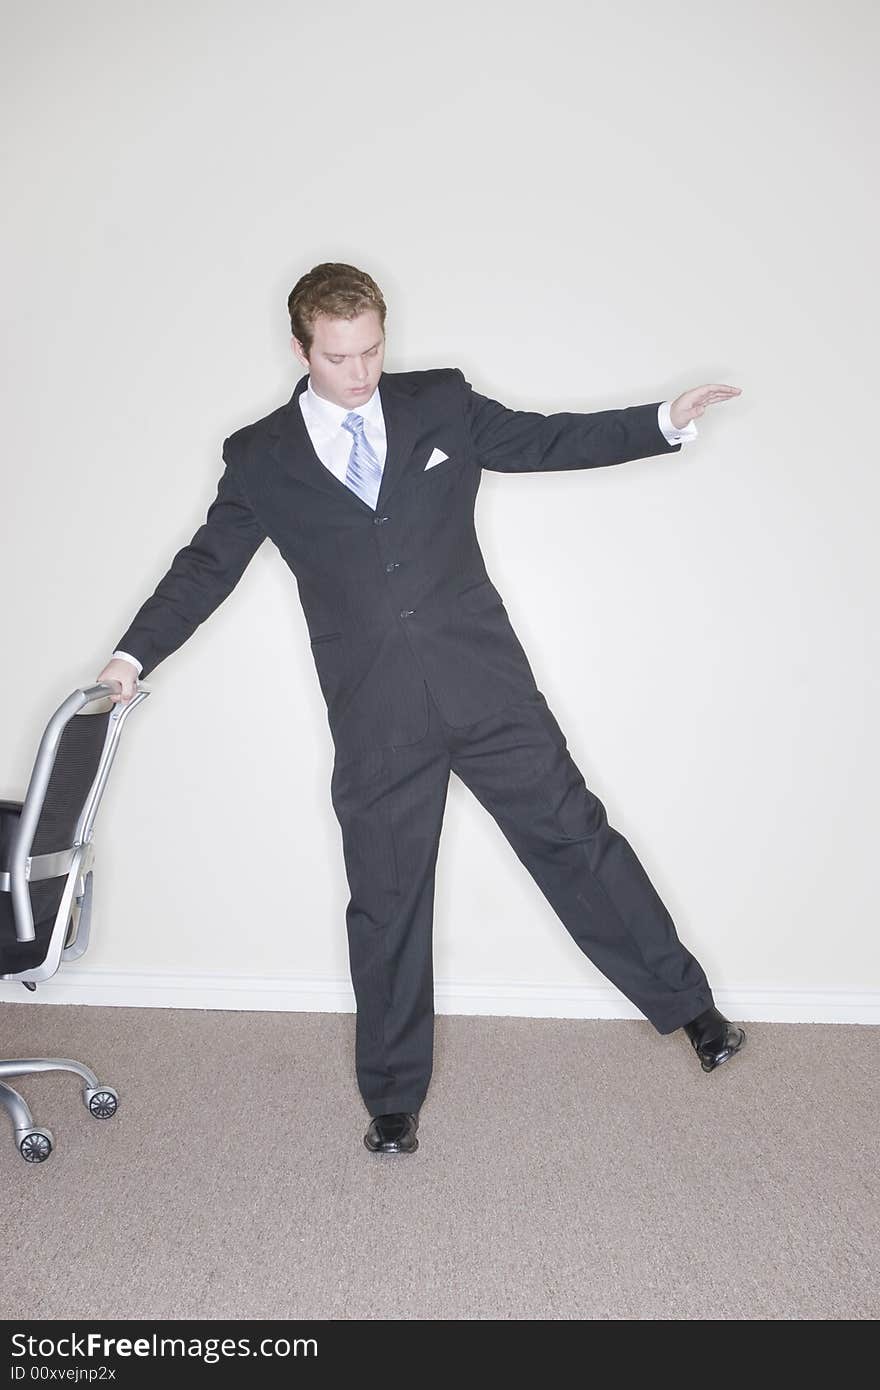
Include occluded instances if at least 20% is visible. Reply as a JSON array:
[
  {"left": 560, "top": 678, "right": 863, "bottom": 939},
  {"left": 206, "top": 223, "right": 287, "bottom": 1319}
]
[{"left": 0, "top": 962, "right": 880, "bottom": 1024}]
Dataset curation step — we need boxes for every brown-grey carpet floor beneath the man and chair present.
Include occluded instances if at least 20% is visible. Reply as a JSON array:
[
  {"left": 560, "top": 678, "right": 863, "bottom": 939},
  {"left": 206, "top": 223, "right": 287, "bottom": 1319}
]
[{"left": 0, "top": 1002, "right": 880, "bottom": 1319}]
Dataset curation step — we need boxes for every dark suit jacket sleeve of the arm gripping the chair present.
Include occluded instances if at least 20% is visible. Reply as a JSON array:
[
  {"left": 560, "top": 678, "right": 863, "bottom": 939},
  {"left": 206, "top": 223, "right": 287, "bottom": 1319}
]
[{"left": 115, "top": 439, "right": 266, "bottom": 676}]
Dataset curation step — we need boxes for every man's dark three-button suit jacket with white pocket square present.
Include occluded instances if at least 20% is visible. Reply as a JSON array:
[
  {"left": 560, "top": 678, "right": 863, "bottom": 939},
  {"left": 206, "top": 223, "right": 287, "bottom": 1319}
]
[{"left": 115, "top": 367, "right": 681, "bottom": 758}]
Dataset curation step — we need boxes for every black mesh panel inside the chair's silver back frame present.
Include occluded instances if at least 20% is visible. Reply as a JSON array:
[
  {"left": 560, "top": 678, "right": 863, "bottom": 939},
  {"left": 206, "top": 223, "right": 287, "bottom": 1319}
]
[{"left": 29, "top": 706, "right": 113, "bottom": 923}]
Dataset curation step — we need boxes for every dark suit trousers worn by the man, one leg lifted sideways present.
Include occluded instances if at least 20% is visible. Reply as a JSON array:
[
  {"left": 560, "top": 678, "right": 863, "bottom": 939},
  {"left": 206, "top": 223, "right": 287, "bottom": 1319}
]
[{"left": 331, "top": 687, "right": 713, "bottom": 1115}]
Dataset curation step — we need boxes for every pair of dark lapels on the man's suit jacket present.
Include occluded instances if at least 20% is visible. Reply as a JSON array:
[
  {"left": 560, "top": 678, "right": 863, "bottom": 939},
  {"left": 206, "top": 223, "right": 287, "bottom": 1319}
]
[{"left": 265, "top": 373, "right": 418, "bottom": 516}]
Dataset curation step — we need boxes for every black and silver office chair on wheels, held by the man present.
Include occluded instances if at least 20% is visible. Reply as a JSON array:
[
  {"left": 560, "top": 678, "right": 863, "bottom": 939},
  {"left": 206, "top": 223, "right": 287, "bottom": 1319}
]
[{"left": 0, "top": 685, "right": 150, "bottom": 1163}]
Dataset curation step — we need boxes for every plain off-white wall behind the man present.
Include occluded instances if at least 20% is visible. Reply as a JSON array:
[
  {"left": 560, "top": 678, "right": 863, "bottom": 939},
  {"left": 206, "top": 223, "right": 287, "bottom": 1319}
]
[{"left": 0, "top": 0, "right": 880, "bottom": 1015}]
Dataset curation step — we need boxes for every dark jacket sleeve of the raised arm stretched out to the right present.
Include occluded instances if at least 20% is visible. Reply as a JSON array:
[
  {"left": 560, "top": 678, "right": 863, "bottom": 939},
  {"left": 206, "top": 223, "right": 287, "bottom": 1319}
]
[{"left": 455, "top": 367, "right": 681, "bottom": 473}]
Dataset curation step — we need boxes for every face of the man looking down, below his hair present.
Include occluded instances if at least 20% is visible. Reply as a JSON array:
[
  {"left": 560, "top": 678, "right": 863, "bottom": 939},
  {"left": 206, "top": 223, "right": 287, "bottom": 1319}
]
[{"left": 292, "top": 309, "right": 385, "bottom": 410}]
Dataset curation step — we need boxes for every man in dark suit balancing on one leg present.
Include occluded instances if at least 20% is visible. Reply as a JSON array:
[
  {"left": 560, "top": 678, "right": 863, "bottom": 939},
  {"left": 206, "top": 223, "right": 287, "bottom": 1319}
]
[{"left": 99, "top": 263, "right": 745, "bottom": 1154}]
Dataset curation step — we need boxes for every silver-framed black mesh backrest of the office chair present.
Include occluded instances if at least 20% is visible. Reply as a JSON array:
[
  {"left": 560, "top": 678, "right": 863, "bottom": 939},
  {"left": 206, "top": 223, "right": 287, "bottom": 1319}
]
[{"left": 0, "top": 685, "right": 150, "bottom": 979}]
